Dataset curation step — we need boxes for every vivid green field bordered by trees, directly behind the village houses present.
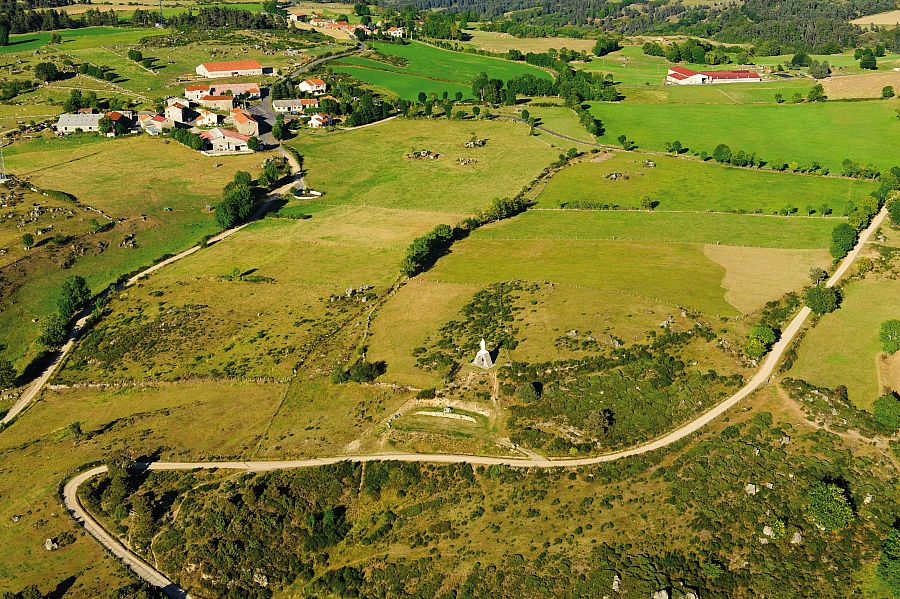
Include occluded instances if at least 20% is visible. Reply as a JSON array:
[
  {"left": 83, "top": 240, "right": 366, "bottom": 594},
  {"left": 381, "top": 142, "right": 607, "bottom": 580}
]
[{"left": 334, "top": 42, "right": 550, "bottom": 99}]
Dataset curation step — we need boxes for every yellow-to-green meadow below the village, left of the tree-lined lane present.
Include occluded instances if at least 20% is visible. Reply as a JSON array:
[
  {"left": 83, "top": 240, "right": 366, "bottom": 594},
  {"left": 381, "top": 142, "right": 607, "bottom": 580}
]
[{"left": 0, "top": 135, "right": 265, "bottom": 367}]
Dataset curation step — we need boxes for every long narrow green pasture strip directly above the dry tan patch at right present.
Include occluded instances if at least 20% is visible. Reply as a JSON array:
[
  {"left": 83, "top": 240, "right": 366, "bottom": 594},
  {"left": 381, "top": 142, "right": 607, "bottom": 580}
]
[{"left": 472, "top": 210, "right": 834, "bottom": 249}]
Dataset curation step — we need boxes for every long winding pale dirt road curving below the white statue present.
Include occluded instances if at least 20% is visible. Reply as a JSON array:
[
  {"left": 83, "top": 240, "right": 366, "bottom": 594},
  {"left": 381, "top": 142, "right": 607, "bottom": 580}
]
[{"left": 63, "top": 208, "right": 887, "bottom": 599}]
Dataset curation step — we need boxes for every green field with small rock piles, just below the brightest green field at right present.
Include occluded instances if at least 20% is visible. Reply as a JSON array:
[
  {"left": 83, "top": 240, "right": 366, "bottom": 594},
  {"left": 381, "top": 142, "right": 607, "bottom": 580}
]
[{"left": 537, "top": 152, "right": 877, "bottom": 215}]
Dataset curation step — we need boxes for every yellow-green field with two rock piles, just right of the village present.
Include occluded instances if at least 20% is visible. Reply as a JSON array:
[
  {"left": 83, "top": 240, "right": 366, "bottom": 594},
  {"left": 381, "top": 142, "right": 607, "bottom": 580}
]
[{"left": 296, "top": 118, "right": 558, "bottom": 212}]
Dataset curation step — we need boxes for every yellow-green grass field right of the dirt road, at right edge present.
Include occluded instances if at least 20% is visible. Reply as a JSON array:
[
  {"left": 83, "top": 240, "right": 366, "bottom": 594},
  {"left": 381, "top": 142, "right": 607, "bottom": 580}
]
[{"left": 789, "top": 280, "right": 900, "bottom": 410}]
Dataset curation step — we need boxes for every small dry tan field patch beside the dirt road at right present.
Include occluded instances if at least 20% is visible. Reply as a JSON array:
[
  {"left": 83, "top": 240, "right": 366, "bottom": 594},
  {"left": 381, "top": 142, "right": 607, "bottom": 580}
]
[{"left": 703, "top": 245, "right": 831, "bottom": 314}]
